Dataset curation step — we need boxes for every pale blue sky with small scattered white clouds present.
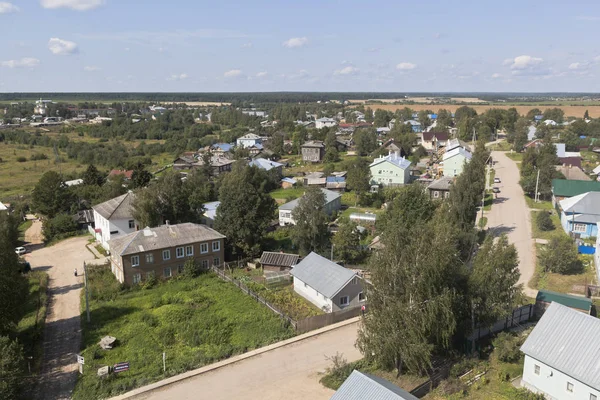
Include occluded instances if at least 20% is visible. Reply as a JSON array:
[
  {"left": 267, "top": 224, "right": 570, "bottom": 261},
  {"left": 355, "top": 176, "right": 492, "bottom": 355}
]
[{"left": 0, "top": 0, "right": 600, "bottom": 92}]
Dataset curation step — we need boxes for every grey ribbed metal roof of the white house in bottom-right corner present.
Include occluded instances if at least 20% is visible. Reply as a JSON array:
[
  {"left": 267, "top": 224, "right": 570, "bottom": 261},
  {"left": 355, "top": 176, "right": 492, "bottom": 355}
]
[{"left": 521, "top": 302, "right": 600, "bottom": 390}]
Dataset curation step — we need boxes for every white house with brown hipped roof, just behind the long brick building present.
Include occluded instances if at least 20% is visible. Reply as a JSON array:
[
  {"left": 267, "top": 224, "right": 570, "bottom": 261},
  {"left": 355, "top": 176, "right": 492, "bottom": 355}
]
[{"left": 92, "top": 192, "right": 140, "bottom": 250}]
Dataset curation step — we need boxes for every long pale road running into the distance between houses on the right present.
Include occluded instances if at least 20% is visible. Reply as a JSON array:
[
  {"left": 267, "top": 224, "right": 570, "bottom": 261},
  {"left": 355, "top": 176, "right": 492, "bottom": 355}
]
[{"left": 487, "top": 151, "right": 537, "bottom": 297}]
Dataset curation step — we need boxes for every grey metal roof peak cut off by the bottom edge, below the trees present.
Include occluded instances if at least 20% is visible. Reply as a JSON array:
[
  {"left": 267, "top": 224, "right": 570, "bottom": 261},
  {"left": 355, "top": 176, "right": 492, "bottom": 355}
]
[{"left": 330, "top": 370, "right": 418, "bottom": 400}]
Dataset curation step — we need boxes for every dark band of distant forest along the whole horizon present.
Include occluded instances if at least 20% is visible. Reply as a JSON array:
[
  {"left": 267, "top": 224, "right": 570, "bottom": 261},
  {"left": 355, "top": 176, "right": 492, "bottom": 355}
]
[{"left": 0, "top": 92, "right": 600, "bottom": 103}]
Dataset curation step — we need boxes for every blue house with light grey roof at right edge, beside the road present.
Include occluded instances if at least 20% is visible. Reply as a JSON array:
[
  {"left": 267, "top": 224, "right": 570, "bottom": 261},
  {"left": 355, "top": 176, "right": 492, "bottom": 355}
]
[{"left": 558, "top": 192, "right": 600, "bottom": 238}]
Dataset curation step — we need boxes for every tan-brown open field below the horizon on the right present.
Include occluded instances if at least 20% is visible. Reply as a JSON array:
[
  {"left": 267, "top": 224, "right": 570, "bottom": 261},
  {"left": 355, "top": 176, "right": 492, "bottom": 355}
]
[{"left": 356, "top": 102, "right": 600, "bottom": 118}]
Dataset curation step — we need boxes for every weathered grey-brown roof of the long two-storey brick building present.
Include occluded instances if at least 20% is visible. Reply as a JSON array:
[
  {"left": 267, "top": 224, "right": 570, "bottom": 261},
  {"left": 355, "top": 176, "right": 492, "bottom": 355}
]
[{"left": 108, "top": 222, "right": 225, "bottom": 255}]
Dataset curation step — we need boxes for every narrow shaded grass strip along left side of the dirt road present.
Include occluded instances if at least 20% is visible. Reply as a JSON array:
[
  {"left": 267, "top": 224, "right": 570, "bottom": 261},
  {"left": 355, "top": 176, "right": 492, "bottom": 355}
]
[{"left": 17, "top": 271, "right": 48, "bottom": 375}]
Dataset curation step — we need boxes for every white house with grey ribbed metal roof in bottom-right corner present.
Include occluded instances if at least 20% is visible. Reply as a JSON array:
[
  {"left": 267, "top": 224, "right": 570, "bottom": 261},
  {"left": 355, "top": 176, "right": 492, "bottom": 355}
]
[{"left": 521, "top": 302, "right": 600, "bottom": 400}]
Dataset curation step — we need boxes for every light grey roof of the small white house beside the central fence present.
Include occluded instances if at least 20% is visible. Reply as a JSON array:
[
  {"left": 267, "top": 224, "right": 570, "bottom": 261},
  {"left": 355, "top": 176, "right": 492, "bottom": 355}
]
[{"left": 291, "top": 252, "right": 357, "bottom": 298}]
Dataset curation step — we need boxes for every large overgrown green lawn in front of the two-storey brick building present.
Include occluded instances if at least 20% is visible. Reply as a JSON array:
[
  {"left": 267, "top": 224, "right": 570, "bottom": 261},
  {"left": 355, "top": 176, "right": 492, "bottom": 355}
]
[{"left": 73, "top": 266, "right": 294, "bottom": 399}]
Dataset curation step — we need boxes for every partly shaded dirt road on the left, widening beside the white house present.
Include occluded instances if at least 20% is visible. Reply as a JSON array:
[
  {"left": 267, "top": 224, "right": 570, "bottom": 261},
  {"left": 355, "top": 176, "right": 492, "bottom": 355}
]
[{"left": 25, "top": 234, "right": 94, "bottom": 400}]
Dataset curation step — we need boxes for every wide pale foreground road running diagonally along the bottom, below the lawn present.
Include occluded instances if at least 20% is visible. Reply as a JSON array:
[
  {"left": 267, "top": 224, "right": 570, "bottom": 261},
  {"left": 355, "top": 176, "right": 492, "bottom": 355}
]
[{"left": 129, "top": 323, "right": 361, "bottom": 400}]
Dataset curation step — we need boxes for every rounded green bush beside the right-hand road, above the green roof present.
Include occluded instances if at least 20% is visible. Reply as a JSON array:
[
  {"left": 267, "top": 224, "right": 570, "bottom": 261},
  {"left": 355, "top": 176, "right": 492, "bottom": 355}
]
[{"left": 538, "top": 235, "right": 583, "bottom": 274}]
